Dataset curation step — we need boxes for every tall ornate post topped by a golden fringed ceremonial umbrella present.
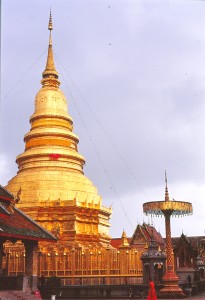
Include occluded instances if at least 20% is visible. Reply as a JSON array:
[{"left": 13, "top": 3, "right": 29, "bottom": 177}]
[{"left": 143, "top": 172, "right": 193, "bottom": 299}]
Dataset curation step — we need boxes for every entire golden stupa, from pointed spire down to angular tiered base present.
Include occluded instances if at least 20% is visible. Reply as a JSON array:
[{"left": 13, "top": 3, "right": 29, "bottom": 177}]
[{"left": 6, "top": 14, "right": 111, "bottom": 246}]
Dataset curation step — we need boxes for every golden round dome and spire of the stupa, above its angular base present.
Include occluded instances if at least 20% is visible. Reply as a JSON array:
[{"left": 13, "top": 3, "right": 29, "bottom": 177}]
[{"left": 6, "top": 15, "right": 104, "bottom": 207}]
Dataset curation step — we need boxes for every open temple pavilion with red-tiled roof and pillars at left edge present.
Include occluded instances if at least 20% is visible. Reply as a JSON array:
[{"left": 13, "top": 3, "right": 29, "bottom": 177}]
[{"left": 0, "top": 185, "right": 57, "bottom": 299}]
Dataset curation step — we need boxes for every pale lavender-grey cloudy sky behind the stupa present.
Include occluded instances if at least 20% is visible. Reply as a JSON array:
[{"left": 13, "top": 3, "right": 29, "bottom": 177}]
[{"left": 0, "top": 0, "right": 205, "bottom": 237}]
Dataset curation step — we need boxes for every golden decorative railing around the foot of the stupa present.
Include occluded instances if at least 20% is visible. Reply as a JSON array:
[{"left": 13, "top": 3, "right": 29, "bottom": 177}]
[{"left": 3, "top": 244, "right": 142, "bottom": 285}]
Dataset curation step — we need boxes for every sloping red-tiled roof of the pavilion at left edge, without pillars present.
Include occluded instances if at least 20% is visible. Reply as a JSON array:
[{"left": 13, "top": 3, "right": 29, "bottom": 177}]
[{"left": 0, "top": 185, "right": 57, "bottom": 242}]
